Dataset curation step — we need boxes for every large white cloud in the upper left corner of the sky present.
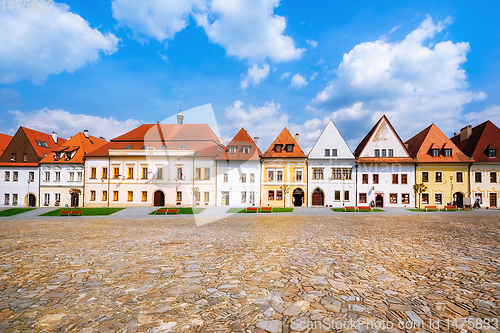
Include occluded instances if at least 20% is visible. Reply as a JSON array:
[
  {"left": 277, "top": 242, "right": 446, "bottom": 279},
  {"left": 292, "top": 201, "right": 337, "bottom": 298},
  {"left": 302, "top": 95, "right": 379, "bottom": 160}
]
[{"left": 0, "top": 4, "right": 119, "bottom": 84}]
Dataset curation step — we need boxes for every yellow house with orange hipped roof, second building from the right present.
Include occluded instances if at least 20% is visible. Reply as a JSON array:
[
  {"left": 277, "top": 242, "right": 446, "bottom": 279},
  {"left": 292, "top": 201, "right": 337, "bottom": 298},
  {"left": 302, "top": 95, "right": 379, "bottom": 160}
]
[{"left": 406, "top": 124, "right": 472, "bottom": 208}]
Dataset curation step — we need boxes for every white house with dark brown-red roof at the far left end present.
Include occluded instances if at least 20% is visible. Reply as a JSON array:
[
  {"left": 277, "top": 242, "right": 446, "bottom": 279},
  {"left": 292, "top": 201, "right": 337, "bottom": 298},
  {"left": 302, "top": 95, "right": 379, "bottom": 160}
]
[{"left": 0, "top": 127, "right": 66, "bottom": 207}]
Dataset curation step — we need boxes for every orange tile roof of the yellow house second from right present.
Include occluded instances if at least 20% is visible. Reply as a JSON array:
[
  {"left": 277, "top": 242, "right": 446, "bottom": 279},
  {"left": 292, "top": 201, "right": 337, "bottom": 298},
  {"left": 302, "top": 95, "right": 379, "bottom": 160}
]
[{"left": 406, "top": 124, "right": 472, "bottom": 163}]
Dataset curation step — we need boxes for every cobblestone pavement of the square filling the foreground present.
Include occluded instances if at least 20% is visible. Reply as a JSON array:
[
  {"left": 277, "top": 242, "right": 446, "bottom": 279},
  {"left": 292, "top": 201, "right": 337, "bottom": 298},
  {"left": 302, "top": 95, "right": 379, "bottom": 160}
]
[{"left": 0, "top": 213, "right": 500, "bottom": 333}]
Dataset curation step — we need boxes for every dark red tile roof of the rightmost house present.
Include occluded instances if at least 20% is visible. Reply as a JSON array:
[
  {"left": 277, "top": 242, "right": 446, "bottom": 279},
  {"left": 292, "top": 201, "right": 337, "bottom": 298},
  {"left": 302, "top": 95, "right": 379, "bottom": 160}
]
[{"left": 451, "top": 120, "right": 500, "bottom": 163}]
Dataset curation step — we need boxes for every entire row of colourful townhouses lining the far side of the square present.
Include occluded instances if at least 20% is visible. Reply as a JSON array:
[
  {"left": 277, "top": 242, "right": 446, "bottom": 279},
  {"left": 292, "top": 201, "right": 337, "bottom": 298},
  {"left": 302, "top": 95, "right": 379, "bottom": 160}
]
[{"left": 0, "top": 113, "right": 500, "bottom": 207}]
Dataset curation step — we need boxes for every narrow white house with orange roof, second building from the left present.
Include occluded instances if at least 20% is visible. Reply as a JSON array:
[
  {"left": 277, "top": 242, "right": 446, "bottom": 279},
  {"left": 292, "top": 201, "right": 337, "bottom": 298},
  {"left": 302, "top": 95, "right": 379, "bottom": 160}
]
[{"left": 39, "top": 131, "right": 107, "bottom": 207}]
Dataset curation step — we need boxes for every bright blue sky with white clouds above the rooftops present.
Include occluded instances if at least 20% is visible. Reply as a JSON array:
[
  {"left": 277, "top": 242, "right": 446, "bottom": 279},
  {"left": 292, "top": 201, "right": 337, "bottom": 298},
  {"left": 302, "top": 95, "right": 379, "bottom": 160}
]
[{"left": 0, "top": 0, "right": 500, "bottom": 150}]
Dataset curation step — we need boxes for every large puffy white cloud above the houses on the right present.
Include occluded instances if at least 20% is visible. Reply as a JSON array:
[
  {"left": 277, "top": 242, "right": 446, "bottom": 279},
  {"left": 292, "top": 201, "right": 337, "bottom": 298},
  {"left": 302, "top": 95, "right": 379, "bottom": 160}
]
[{"left": 314, "top": 17, "right": 486, "bottom": 140}]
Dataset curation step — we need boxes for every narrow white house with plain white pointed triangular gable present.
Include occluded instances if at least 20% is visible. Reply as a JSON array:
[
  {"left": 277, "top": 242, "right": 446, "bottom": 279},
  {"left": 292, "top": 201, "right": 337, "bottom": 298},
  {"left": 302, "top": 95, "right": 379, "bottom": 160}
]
[{"left": 307, "top": 120, "right": 356, "bottom": 207}]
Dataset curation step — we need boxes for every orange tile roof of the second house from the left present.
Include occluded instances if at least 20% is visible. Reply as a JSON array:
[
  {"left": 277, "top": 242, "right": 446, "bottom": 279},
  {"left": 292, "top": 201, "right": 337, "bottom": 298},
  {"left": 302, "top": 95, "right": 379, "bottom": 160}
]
[{"left": 40, "top": 132, "right": 108, "bottom": 163}]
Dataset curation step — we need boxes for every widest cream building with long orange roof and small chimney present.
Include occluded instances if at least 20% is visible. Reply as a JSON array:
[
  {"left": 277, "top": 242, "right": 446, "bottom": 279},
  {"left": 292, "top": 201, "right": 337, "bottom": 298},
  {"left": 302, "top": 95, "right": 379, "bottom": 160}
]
[{"left": 84, "top": 115, "right": 224, "bottom": 207}]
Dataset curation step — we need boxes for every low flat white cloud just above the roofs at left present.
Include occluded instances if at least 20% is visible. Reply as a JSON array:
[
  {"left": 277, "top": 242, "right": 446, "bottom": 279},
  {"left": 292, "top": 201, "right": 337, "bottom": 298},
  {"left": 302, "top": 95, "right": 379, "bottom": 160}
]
[{"left": 9, "top": 109, "right": 144, "bottom": 140}]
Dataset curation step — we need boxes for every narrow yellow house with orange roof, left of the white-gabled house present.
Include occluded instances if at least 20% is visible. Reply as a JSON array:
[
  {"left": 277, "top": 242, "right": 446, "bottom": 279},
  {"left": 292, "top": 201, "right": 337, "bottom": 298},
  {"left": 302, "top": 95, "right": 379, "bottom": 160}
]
[{"left": 261, "top": 128, "right": 307, "bottom": 207}]
